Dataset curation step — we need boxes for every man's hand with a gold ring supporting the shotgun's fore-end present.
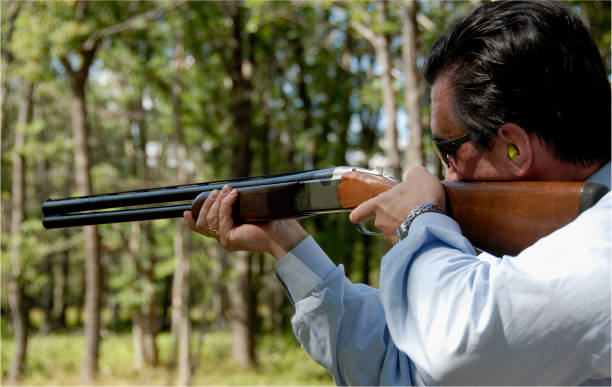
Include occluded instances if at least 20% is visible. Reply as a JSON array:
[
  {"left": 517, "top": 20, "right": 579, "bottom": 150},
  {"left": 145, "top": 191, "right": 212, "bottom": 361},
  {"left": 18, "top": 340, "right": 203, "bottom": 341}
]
[{"left": 183, "top": 185, "right": 308, "bottom": 259}]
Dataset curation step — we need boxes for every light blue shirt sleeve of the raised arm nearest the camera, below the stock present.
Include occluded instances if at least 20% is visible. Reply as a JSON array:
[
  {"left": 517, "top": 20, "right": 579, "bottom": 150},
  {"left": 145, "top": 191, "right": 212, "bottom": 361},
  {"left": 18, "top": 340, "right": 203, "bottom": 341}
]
[{"left": 380, "top": 194, "right": 611, "bottom": 385}]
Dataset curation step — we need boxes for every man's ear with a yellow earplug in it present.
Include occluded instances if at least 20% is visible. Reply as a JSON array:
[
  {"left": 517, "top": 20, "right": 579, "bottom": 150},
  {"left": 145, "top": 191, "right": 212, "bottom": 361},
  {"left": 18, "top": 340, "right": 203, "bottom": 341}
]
[{"left": 496, "top": 122, "right": 533, "bottom": 178}]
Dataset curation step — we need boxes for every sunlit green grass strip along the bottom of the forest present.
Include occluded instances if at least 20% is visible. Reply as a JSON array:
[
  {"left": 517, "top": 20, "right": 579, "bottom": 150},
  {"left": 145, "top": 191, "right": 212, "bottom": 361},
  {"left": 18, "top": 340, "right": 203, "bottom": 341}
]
[{"left": 0, "top": 332, "right": 333, "bottom": 386}]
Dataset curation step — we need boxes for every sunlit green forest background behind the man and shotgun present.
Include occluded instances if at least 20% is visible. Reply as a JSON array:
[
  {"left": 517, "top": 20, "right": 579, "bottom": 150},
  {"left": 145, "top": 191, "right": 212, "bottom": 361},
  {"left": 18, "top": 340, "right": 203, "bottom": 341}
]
[{"left": 0, "top": 0, "right": 610, "bottom": 385}]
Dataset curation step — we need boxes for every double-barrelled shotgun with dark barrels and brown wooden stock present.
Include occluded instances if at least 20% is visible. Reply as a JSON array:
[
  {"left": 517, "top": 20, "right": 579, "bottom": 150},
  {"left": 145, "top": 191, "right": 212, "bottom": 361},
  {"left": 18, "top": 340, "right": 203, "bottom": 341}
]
[{"left": 42, "top": 167, "right": 608, "bottom": 255}]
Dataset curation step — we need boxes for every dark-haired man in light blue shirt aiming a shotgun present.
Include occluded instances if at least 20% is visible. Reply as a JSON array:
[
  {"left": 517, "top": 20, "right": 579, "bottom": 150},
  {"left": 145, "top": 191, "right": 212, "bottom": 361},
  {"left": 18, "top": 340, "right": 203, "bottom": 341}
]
[{"left": 185, "top": 2, "right": 612, "bottom": 385}]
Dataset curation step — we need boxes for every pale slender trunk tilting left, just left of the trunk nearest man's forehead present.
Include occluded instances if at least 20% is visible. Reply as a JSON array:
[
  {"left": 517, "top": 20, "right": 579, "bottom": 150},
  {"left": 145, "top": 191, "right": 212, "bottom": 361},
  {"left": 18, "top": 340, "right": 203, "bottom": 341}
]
[{"left": 374, "top": 1, "right": 402, "bottom": 178}]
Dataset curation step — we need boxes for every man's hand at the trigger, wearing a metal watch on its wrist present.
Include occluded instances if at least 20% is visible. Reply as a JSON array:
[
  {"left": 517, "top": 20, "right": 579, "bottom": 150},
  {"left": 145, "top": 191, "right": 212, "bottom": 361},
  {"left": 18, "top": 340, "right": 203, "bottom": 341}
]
[{"left": 350, "top": 167, "right": 446, "bottom": 244}]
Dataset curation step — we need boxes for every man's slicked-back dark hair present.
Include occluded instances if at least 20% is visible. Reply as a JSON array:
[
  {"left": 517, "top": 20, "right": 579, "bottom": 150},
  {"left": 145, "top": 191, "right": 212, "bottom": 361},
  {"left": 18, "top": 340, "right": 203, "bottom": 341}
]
[{"left": 425, "top": 1, "right": 611, "bottom": 165}]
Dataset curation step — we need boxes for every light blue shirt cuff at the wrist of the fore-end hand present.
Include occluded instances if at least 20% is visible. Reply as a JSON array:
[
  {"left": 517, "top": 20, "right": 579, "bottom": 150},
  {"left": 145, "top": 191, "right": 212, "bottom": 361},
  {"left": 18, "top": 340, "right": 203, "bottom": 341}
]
[{"left": 275, "top": 236, "right": 336, "bottom": 305}]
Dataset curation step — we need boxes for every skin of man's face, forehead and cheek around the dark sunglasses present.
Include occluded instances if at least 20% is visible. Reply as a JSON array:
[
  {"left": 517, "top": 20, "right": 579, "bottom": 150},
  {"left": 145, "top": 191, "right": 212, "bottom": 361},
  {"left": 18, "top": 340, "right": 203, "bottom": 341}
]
[{"left": 431, "top": 75, "right": 512, "bottom": 181}]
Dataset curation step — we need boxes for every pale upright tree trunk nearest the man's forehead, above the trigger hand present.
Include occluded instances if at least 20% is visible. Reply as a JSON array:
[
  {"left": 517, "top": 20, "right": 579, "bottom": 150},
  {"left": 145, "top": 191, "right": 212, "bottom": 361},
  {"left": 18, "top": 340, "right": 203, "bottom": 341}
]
[{"left": 401, "top": 0, "right": 424, "bottom": 170}]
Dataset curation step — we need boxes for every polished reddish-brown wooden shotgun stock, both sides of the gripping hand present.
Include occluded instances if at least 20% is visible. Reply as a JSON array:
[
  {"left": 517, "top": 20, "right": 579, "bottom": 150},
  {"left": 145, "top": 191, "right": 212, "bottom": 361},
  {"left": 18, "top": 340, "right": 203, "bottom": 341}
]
[{"left": 338, "top": 172, "right": 608, "bottom": 255}]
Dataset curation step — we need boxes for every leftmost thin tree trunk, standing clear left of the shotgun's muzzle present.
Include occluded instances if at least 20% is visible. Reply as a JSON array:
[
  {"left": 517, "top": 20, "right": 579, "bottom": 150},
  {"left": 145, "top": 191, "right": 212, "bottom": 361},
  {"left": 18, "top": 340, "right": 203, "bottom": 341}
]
[{"left": 7, "top": 81, "right": 34, "bottom": 382}]
